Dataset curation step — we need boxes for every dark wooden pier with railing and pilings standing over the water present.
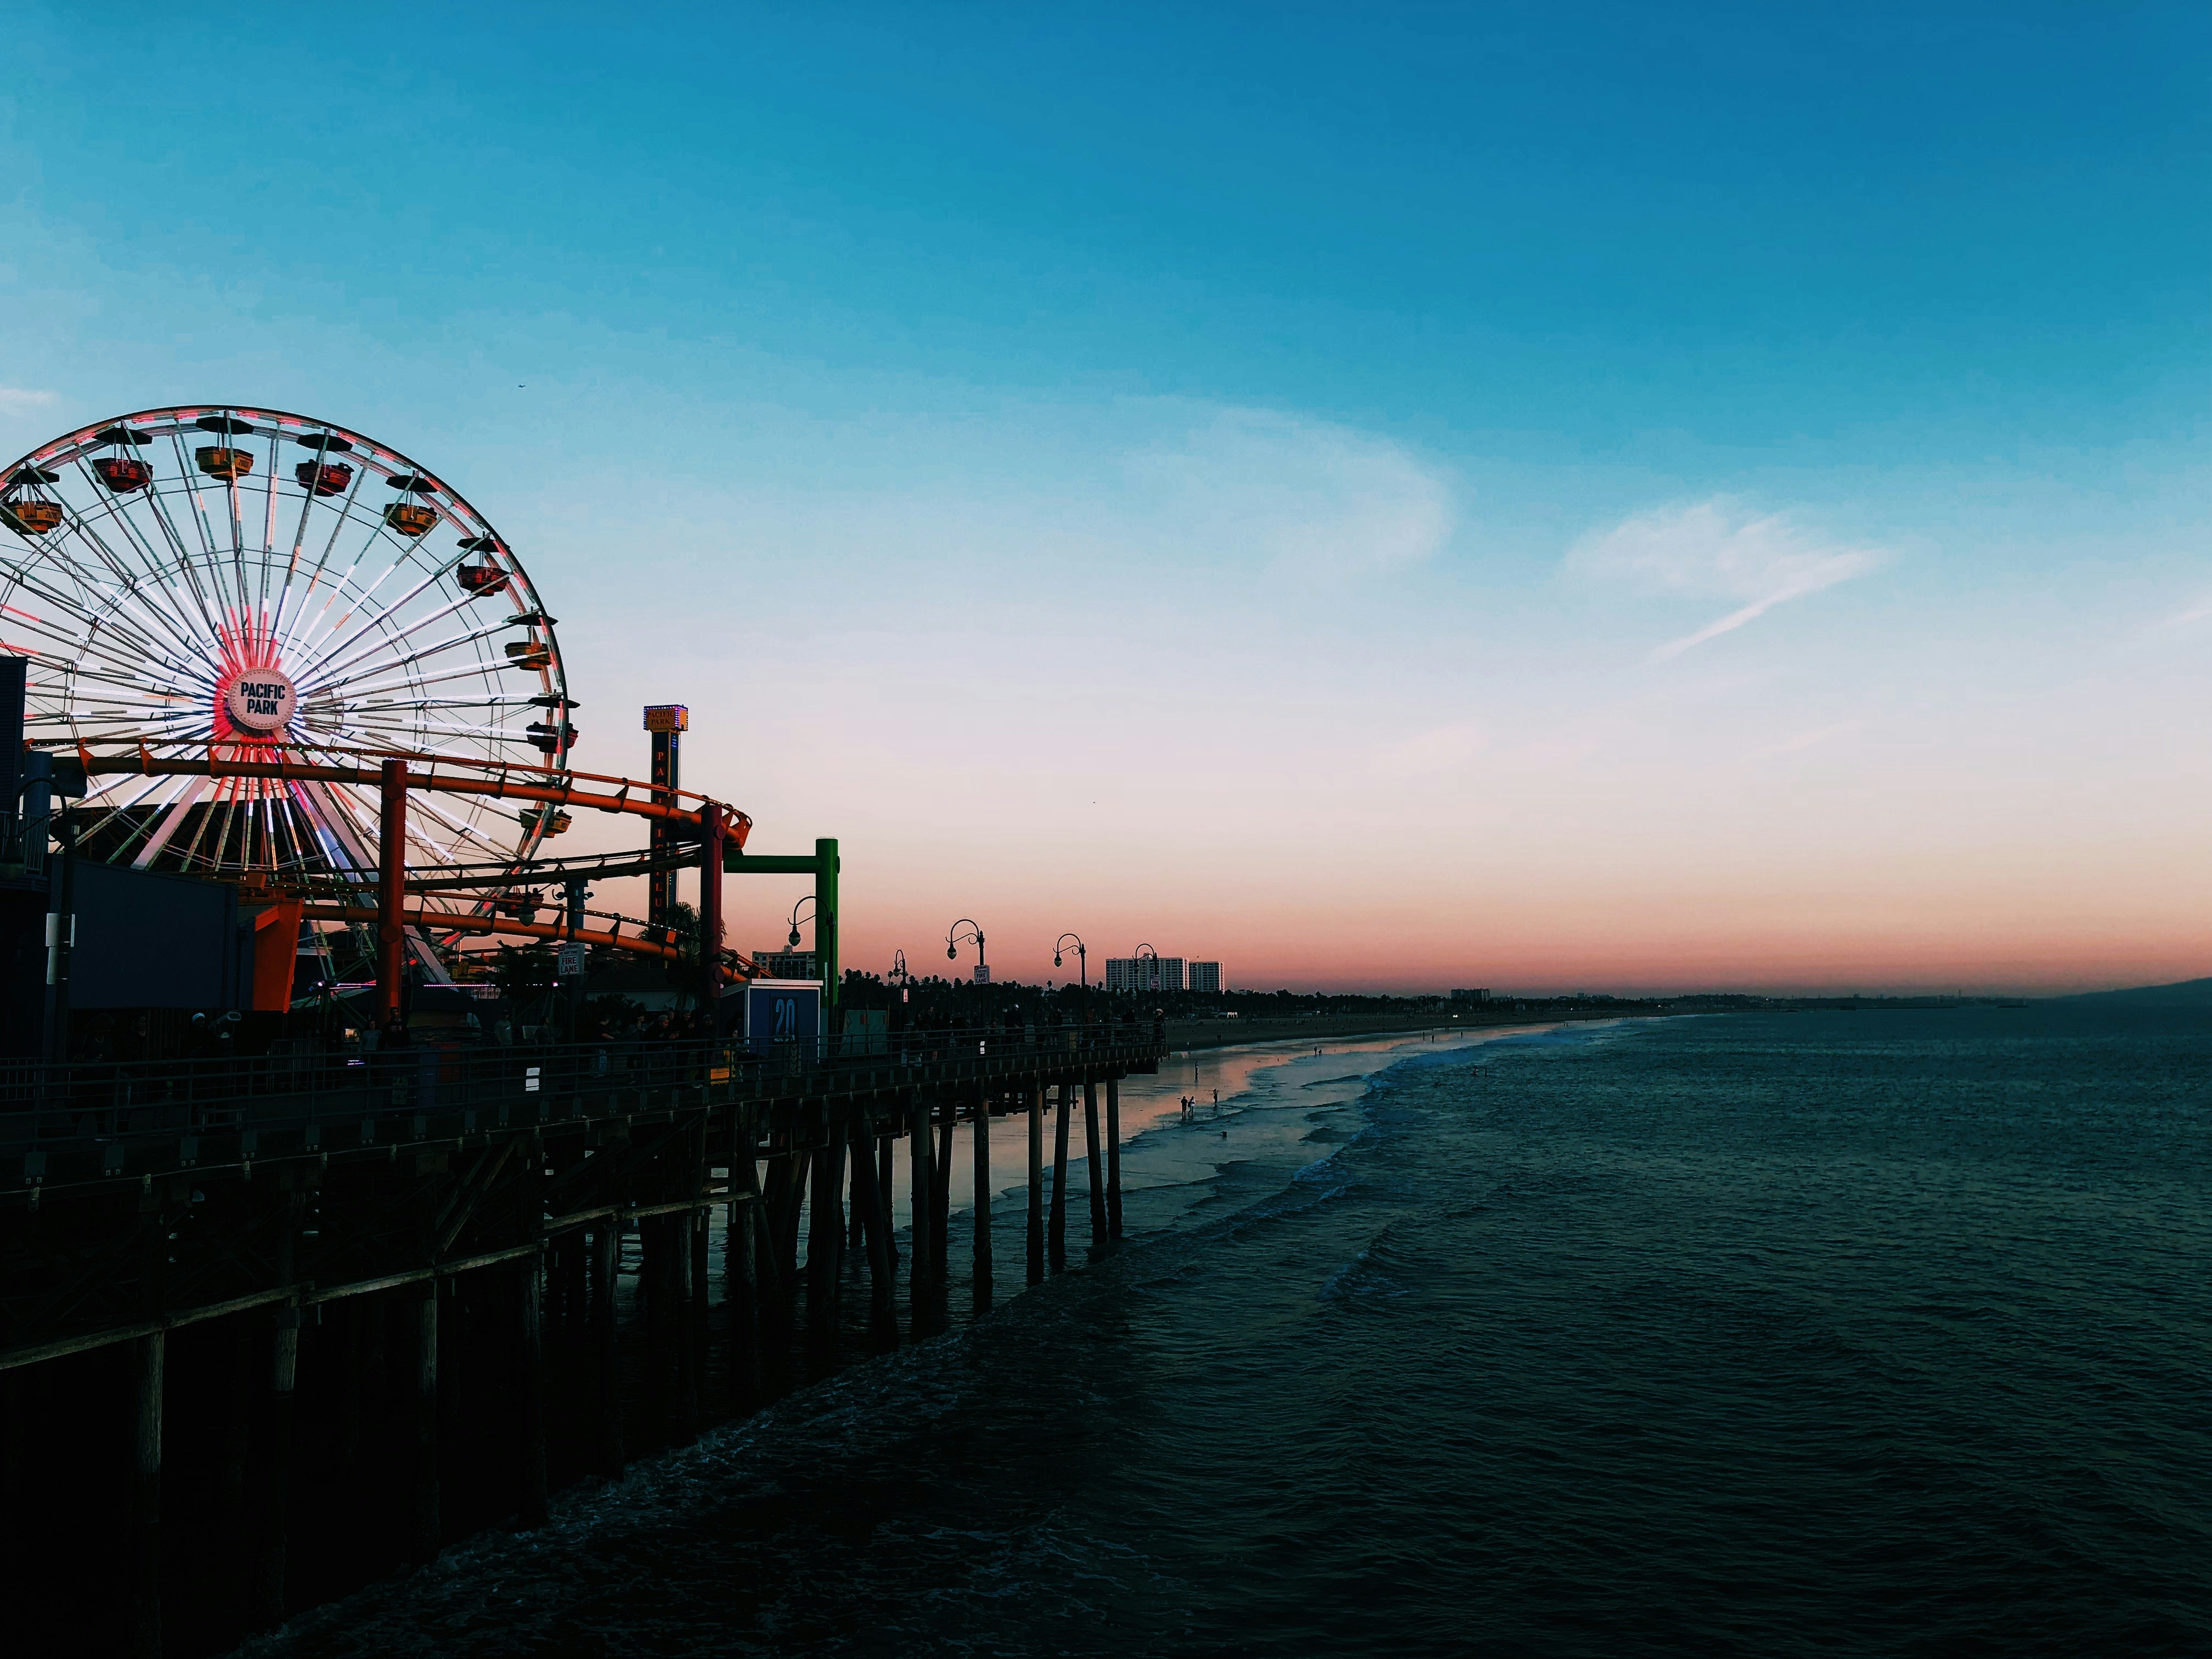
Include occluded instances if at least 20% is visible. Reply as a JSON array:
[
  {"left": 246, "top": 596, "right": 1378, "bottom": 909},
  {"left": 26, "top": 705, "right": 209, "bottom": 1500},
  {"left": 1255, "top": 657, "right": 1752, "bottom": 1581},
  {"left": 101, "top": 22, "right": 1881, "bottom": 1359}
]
[{"left": 0, "top": 1024, "right": 1164, "bottom": 1655}]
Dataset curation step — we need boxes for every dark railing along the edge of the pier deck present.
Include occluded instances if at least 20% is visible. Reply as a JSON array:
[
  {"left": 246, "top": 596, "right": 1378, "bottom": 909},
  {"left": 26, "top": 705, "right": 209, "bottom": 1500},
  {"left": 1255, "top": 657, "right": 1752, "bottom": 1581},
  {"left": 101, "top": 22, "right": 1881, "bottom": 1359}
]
[{"left": 0, "top": 1024, "right": 1161, "bottom": 1192}]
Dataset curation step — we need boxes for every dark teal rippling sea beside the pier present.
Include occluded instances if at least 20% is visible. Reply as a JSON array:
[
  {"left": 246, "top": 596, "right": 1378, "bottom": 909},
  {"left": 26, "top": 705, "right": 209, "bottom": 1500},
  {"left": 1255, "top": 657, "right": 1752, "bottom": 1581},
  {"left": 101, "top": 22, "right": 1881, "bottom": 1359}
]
[{"left": 250, "top": 1009, "right": 2212, "bottom": 1657}]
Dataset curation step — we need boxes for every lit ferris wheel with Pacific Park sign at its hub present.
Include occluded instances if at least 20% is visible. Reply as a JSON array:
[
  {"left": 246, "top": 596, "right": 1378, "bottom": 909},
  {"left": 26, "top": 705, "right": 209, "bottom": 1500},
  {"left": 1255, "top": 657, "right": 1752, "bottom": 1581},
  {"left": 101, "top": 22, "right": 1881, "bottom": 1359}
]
[{"left": 0, "top": 407, "right": 577, "bottom": 960}]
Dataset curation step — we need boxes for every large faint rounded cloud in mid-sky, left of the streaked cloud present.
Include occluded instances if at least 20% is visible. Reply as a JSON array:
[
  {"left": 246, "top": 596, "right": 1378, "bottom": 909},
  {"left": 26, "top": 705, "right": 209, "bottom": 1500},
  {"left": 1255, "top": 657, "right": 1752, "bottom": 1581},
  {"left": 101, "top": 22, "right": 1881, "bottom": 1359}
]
[{"left": 1128, "top": 409, "right": 1458, "bottom": 577}]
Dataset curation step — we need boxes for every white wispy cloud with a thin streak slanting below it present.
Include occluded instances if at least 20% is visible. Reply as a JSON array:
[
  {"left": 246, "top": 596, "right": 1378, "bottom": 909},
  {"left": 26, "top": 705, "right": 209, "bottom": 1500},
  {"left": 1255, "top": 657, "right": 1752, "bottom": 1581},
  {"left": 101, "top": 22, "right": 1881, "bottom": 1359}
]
[{"left": 1566, "top": 495, "right": 1880, "bottom": 662}]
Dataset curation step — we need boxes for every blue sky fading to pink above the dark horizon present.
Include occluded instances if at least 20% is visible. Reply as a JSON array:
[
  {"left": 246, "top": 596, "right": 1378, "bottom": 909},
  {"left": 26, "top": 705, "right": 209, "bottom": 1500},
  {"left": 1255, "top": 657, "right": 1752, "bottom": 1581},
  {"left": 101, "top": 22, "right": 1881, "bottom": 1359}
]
[{"left": 0, "top": 4, "right": 2212, "bottom": 984}]
